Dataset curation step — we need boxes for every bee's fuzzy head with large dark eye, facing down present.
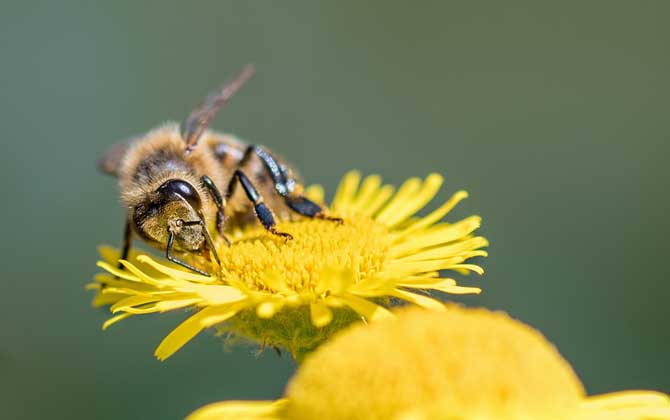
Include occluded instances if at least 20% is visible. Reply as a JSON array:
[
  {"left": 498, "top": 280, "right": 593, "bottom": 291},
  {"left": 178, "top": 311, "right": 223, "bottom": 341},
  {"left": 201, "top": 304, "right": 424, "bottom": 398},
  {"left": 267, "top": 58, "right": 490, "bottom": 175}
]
[{"left": 132, "top": 179, "right": 206, "bottom": 251}]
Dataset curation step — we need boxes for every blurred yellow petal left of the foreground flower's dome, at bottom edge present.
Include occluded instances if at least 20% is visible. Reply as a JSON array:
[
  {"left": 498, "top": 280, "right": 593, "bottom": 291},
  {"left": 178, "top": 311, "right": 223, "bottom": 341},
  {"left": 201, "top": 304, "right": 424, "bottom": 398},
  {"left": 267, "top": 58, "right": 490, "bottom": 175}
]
[{"left": 186, "top": 399, "right": 288, "bottom": 420}]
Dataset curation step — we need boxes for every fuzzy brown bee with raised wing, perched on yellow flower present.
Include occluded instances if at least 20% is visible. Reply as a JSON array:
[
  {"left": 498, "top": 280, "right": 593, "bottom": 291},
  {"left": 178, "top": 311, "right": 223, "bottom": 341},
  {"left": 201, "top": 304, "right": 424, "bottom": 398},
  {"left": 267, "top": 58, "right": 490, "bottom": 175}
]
[{"left": 98, "top": 66, "right": 342, "bottom": 276}]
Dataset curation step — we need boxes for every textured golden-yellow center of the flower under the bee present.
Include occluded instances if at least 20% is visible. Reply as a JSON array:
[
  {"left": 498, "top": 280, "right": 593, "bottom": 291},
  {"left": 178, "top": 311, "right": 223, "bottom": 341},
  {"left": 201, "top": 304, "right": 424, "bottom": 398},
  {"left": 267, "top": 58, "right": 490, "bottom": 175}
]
[{"left": 219, "top": 216, "right": 390, "bottom": 292}]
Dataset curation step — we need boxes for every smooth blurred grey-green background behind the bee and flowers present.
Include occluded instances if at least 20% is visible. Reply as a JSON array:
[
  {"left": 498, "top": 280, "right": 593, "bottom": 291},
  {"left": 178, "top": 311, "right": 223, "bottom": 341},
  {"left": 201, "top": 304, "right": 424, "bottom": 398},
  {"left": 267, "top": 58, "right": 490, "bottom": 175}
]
[{"left": 0, "top": 0, "right": 670, "bottom": 419}]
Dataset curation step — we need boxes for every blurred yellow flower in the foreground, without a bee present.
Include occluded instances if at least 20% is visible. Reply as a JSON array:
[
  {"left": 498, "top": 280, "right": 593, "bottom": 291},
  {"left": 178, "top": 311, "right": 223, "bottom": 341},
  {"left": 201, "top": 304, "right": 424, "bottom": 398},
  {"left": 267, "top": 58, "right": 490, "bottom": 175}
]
[{"left": 187, "top": 305, "right": 670, "bottom": 420}]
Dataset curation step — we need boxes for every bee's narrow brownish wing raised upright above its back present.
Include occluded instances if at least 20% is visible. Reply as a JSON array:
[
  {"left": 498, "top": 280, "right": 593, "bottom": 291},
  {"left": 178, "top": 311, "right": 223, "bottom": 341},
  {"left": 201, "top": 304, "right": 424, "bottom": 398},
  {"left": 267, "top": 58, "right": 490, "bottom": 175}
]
[{"left": 182, "top": 65, "right": 255, "bottom": 155}]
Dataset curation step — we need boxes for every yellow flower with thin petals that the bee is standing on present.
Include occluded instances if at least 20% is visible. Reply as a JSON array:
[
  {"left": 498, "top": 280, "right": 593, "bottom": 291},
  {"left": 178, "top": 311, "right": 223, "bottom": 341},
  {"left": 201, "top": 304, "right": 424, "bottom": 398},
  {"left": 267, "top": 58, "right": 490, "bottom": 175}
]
[{"left": 90, "top": 172, "right": 488, "bottom": 360}]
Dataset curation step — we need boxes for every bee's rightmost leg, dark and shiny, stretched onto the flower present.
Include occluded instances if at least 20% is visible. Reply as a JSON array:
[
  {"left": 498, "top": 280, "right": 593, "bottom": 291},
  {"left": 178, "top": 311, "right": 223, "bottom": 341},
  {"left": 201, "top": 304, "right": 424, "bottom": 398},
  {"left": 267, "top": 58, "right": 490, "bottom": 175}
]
[{"left": 240, "top": 144, "right": 342, "bottom": 223}]
